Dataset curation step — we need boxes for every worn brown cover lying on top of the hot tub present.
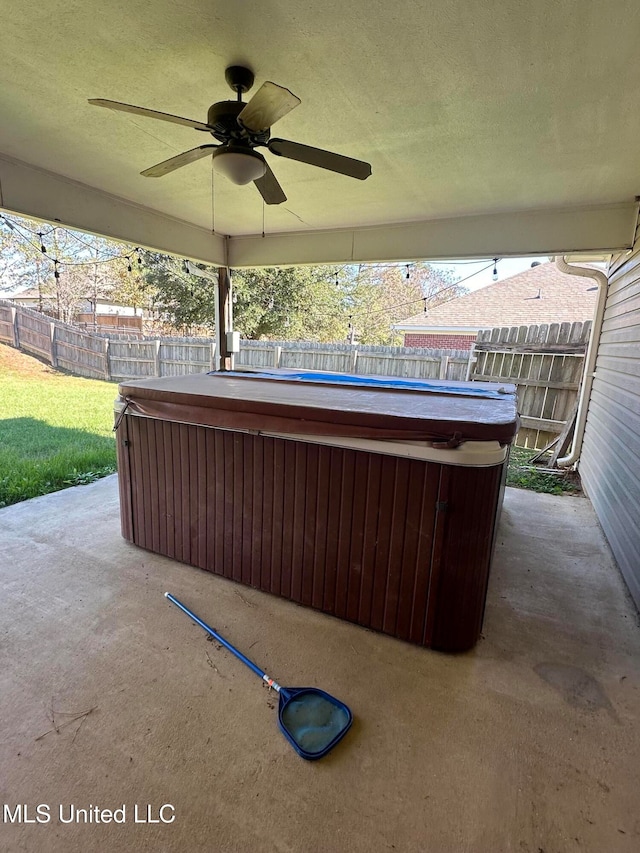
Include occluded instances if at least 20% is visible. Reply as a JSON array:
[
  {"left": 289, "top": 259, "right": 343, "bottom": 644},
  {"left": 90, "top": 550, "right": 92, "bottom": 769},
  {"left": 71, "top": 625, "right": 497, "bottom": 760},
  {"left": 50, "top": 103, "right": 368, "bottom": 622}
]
[{"left": 120, "top": 371, "right": 518, "bottom": 446}]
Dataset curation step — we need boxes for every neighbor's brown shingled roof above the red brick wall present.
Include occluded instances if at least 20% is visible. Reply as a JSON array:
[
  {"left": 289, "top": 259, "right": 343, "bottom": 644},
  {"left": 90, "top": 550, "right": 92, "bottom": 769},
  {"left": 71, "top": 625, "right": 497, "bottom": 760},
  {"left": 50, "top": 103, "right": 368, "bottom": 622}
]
[{"left": 393, "top": 263, "right": 597, "bottom": 333}]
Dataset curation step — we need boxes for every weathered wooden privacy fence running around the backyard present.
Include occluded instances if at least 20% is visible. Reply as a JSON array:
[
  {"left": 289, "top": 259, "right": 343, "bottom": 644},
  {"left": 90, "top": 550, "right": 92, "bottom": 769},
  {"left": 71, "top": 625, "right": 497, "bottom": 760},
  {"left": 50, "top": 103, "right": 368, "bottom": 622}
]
[{"left": 0, "top": 300, "right": 591, "bottom": 449}]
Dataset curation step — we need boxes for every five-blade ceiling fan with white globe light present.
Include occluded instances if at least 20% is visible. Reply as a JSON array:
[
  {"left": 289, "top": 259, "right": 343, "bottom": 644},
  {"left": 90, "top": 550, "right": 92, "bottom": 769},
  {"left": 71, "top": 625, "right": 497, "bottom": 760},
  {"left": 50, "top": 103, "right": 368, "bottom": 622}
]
[{"left": 89, "top": 65, "right": 371, "bottom": 204}]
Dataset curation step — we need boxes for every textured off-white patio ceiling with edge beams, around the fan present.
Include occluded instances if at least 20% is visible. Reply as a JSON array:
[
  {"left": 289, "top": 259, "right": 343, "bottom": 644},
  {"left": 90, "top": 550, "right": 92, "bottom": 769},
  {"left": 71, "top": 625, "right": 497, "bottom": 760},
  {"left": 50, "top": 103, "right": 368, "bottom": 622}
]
[{"left": 0, "top": 0, "right": 640, "bottom": 263}]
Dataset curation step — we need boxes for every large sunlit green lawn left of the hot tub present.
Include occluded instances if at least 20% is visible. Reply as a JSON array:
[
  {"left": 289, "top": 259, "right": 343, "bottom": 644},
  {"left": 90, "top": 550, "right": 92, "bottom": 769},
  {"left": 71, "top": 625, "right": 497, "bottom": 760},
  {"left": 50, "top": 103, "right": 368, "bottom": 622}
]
[{"left": 0, "top": 344, "right": 118, "bottom": 507}]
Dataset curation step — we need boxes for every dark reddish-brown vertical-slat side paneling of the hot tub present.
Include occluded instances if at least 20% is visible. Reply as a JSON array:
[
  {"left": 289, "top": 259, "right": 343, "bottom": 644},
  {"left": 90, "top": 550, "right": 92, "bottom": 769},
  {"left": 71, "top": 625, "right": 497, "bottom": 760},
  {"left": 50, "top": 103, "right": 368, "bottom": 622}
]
[{"left": 118, "top": 415, "right": 502, "bottom": 651}]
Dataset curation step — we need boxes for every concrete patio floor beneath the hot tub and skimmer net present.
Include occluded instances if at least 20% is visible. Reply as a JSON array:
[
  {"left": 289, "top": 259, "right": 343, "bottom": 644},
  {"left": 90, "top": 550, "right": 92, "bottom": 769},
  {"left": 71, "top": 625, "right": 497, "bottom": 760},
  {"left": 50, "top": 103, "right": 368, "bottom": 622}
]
[{"left": 0, "top": 475, "right": 640, "bottom": 853}]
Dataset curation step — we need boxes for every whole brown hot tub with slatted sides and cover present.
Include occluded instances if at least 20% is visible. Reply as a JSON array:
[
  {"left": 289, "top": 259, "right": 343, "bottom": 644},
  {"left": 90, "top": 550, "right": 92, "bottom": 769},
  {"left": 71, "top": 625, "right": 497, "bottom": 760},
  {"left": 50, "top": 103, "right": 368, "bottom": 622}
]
[{"left": 116, "top": 370, "right": 518, "bottom": 651}]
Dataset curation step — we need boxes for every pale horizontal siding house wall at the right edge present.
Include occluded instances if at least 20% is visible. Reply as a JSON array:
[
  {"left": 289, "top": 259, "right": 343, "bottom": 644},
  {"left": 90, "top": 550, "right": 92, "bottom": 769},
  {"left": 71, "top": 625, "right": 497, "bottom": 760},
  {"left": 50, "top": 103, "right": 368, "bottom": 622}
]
[{"left": 580, "top": 241, "right": 640, "bottom": 607}]
